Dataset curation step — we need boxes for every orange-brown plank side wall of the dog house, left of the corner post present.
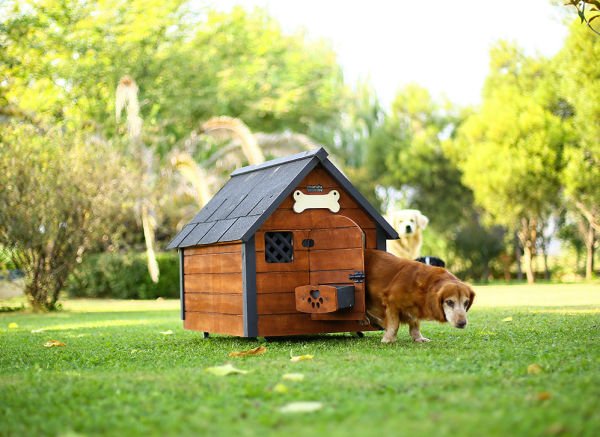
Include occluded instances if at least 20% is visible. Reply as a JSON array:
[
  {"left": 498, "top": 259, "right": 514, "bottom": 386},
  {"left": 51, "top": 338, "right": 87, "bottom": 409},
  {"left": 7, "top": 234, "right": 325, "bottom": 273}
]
[{"left": 183, "top": 242, "right": 244, "bottom": 336}]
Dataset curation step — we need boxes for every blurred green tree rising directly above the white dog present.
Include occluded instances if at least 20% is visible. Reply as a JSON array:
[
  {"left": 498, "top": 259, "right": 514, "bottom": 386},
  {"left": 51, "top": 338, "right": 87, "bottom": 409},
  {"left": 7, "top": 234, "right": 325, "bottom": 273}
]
[{"left": 367, "top": 85, "right": 472, "bottom": 234}]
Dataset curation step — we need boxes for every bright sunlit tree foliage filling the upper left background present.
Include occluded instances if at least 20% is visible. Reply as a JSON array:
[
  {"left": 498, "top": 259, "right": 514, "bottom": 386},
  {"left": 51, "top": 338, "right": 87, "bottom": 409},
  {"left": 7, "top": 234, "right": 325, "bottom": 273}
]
[{"left": 0, "top": 0, "right": 344, "bottom": 155}]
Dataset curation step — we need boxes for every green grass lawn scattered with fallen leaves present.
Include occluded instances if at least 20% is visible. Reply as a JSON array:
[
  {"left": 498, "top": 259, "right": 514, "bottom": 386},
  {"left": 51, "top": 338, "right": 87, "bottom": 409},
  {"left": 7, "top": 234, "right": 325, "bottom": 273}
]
[{"left": 0, "top": 285, "right": 600, "bottom": 437}]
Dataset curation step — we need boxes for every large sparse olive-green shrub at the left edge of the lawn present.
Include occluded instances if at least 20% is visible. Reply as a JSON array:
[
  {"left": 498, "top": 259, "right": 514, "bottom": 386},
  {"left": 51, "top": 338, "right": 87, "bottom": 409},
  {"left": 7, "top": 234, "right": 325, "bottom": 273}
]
[{"left": 0, "top": 125, "right": 132, "bottom": 310}]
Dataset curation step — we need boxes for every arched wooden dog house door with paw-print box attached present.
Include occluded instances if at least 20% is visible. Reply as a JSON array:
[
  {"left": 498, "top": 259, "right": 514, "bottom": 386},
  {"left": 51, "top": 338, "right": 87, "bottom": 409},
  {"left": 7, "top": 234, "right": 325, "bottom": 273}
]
[{"left": 296, "top": 215, "right": 365, "bottom": 321}]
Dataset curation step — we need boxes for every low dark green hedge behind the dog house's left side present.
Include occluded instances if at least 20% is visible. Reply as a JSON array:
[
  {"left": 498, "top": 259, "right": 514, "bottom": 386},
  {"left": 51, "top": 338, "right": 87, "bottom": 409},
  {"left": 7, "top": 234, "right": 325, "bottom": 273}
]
[{"left": 65, "top": 252, "right": 179, "bottom": 299}]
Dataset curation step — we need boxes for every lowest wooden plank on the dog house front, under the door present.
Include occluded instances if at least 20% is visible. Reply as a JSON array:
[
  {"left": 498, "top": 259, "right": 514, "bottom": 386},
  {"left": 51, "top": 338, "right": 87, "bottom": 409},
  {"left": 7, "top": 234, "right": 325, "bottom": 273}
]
[{"left": 258, "top": 313, "right": 376, "bottom": 337}]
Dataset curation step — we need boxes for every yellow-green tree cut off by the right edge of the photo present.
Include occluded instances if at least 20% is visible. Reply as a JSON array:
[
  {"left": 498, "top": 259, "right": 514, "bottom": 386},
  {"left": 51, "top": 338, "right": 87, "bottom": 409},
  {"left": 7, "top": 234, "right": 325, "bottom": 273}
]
[{"left": 556, "top": 23, "right": 600, "bottom": 279}]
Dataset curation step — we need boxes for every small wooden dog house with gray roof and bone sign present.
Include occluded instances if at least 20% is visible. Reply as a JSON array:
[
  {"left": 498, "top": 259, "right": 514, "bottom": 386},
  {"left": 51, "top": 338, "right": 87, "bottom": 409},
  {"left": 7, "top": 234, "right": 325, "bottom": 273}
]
[{"left": 168, "top": 148, "right": 398, "bottom": 337}]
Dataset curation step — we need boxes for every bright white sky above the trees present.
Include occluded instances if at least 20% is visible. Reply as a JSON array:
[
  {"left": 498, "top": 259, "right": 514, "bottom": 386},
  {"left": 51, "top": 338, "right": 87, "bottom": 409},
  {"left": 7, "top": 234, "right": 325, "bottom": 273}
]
[{"left": 215, "top": 0, "right": 574, "bottom": 105}]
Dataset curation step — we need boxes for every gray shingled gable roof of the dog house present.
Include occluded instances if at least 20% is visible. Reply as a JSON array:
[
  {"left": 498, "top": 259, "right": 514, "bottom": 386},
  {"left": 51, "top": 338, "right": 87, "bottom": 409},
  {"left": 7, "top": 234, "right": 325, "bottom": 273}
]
[{"left": 167, "top": 148, "right": 398, "bottom": 249}]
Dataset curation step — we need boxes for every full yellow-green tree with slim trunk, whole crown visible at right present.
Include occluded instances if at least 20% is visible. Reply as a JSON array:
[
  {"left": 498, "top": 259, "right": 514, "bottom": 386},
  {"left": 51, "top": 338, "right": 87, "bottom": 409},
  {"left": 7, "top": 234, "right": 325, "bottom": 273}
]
[{"left": 453, "top": 42, "right": 566, "bottom": 283}]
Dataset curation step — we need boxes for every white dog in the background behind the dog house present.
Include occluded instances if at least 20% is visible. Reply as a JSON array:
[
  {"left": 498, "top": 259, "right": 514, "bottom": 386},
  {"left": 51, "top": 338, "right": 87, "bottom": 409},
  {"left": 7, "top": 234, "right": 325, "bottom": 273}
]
[{"left": 386, "top": 209, "right": 429, "bottom": 260}]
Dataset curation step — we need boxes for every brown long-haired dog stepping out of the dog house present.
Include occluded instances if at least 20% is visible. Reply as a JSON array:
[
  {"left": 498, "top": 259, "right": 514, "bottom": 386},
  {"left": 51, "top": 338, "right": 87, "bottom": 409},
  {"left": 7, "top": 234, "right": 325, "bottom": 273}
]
[{"left": 365, "top": 250, "right": 475, "bottom": 343}]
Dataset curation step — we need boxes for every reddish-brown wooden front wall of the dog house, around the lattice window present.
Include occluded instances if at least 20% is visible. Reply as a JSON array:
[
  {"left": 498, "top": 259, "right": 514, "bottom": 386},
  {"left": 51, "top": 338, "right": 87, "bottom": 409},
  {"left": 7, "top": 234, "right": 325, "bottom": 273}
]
[{"left": 255, "top": 167, "right": 377, "bottom": 336}]
